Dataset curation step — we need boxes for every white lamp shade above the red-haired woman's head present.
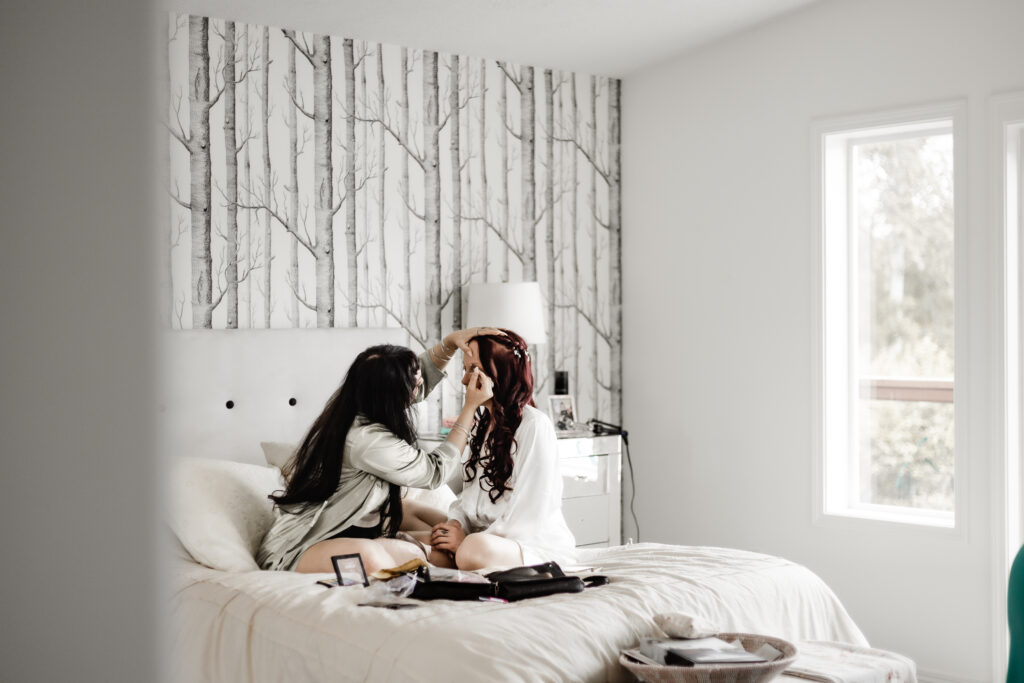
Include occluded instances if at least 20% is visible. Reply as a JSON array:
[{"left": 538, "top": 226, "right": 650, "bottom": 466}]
[{"left": 465, "top": 283, "right": 548, "bottom": 344}]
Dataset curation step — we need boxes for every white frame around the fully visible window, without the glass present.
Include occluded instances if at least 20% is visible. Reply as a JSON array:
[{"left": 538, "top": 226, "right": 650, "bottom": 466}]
[{"left": 811, "top": 100, "right": 969, "bottom": 536}]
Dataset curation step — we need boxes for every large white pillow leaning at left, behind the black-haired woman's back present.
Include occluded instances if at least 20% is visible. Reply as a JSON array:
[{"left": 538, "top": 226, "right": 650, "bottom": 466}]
[{"left": 169, "top": 458, "right": 284, "bottom": 571}]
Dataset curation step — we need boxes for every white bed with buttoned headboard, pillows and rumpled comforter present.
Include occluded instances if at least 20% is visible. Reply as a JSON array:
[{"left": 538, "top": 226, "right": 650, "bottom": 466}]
[{"left": 162, "top": 330, "right": 866, "bottom": 683}]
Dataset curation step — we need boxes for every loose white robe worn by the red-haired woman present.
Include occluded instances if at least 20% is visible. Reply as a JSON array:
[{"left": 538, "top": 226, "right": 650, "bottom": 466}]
[{"left": 449, "top": 405, "right": 575, "bottom": 564}]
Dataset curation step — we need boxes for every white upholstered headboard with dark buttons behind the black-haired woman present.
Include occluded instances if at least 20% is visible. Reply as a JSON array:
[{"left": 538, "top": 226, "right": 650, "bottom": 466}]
[{"left": 158, "top": 328, "right": 408, "bottom": 465}]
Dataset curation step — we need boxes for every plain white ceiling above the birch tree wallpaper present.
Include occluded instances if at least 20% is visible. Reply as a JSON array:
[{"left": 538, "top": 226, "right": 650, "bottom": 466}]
[{"left": 161, "top": 0, "right": 819, "bottom": 77}]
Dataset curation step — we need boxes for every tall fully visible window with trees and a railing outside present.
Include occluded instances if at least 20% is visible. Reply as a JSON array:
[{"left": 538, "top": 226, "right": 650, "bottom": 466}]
[{"left": 816, "top": 105, "right": 957, "bottom": 527}]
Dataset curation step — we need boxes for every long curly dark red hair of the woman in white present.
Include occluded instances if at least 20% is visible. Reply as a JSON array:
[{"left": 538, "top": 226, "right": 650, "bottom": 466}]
[{"left": 463, "top": 330, "right": 536, "bottom": 503}]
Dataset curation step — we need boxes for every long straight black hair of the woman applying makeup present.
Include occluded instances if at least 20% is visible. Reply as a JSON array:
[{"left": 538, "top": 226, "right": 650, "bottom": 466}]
[{"left": 270, "top": 344, "right": 420, "bottom": 537}]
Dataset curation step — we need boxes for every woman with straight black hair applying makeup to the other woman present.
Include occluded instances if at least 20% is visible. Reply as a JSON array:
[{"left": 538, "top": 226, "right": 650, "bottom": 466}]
[{"left": 256, "top": 328, "right": 501, "bottom": 572}]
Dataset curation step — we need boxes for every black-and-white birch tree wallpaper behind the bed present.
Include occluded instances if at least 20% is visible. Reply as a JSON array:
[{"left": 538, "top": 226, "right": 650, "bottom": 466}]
[{"left": 161, "top": 14, "right": 622, "bottom": 421}]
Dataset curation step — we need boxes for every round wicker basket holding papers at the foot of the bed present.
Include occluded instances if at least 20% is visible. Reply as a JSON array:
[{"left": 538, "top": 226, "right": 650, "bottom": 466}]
[{"left": 618, "top": 633, "right": 797, "bottom": 683}]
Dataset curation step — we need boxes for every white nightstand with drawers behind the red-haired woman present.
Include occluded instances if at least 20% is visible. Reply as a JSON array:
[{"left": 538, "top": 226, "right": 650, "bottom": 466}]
[{"left": 419, "top": 434, "right": 623, "bottom": 548}]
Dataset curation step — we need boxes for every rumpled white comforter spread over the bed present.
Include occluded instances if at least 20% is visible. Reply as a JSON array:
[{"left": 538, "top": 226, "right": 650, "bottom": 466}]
[{"left": 170, "top": 544, "right": 866, "bottom": 683}]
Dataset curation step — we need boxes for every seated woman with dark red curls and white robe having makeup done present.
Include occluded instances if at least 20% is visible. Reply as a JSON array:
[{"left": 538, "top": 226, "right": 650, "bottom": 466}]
[{"left": 430, "top": 330, "right": 575, "bottom": 569}]
